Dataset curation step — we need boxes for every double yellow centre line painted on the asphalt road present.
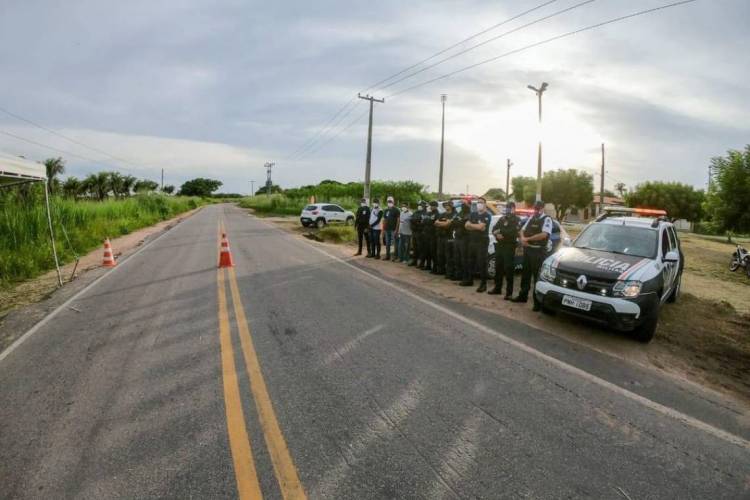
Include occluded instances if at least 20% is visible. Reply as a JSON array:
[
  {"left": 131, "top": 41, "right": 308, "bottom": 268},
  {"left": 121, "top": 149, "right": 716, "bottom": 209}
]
[{"left": 218, "top": 225, "right": 307, "bottom": 499}]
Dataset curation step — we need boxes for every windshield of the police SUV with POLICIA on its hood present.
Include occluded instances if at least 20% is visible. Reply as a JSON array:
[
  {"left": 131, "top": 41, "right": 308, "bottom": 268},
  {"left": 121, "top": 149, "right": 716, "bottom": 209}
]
[{"left": 574, "top": 224, "right": 658, "bottom": 258}]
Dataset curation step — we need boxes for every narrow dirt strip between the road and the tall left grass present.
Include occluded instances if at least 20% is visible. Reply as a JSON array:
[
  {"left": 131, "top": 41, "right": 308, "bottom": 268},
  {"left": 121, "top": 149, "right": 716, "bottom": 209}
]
[{"left": 0, "top": 208, "right": 200, "bottom": 320}]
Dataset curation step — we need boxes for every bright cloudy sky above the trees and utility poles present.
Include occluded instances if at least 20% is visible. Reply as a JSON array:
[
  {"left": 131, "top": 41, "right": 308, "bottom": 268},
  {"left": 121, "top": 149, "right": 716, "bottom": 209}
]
[{"left": 0, "top": 0, "right": 750, "bottom": 193}]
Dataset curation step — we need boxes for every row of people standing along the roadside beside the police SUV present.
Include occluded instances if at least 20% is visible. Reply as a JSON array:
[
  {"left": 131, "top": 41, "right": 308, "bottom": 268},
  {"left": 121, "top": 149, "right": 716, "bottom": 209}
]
[{"left": 355, "top": 196, "right": 553, "bottom": 310}]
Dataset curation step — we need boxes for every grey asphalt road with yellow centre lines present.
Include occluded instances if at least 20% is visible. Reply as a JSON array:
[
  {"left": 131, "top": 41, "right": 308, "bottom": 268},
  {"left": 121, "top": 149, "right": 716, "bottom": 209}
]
[{"left": 0, "top": 205, "right": 750, "bottom": 499}]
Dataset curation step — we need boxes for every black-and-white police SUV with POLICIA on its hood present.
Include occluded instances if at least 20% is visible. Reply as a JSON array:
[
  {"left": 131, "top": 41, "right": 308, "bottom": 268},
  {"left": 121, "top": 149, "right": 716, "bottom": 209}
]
[{"left": 535, "top": 207, "right": 684, "bottom": 342}]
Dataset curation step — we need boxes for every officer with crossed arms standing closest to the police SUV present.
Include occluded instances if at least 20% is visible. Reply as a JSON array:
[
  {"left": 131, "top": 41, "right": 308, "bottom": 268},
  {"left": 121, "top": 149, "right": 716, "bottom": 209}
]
[{"left": 511, "top": 200, "right": 552, "bottom": 311}]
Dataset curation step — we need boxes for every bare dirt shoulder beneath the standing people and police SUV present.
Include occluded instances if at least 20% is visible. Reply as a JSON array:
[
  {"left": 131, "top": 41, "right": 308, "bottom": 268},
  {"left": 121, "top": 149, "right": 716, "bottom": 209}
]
[{"left": 264, "top": 217, "right": 750, "bottom": 404}]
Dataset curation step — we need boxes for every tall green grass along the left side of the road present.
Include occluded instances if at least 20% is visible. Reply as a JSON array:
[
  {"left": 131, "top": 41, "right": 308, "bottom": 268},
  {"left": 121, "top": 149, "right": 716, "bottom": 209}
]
[{"left": 0, "top": 195, "right": 203, "bottom": 287}]
